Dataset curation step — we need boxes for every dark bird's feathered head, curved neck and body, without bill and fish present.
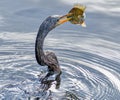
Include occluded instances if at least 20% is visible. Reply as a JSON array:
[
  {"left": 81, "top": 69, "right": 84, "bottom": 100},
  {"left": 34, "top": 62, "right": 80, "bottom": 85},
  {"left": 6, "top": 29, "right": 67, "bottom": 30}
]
[{"left": 35, "top": 16, "right": 65, "bottom": 77}]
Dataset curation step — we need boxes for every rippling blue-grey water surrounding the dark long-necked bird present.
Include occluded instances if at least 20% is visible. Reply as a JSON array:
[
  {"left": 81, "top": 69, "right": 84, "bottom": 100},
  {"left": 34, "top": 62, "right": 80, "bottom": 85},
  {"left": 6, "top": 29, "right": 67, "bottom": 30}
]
[{"left": 0, "top": 0, "right": 120, "bottom": 100}]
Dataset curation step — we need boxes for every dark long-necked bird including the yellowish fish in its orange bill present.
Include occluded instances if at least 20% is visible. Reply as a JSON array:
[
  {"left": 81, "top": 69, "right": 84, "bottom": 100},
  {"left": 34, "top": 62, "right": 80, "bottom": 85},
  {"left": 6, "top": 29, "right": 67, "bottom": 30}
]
[{"left": 35, "top": 5, "right": 85, "bottom": 80}]
